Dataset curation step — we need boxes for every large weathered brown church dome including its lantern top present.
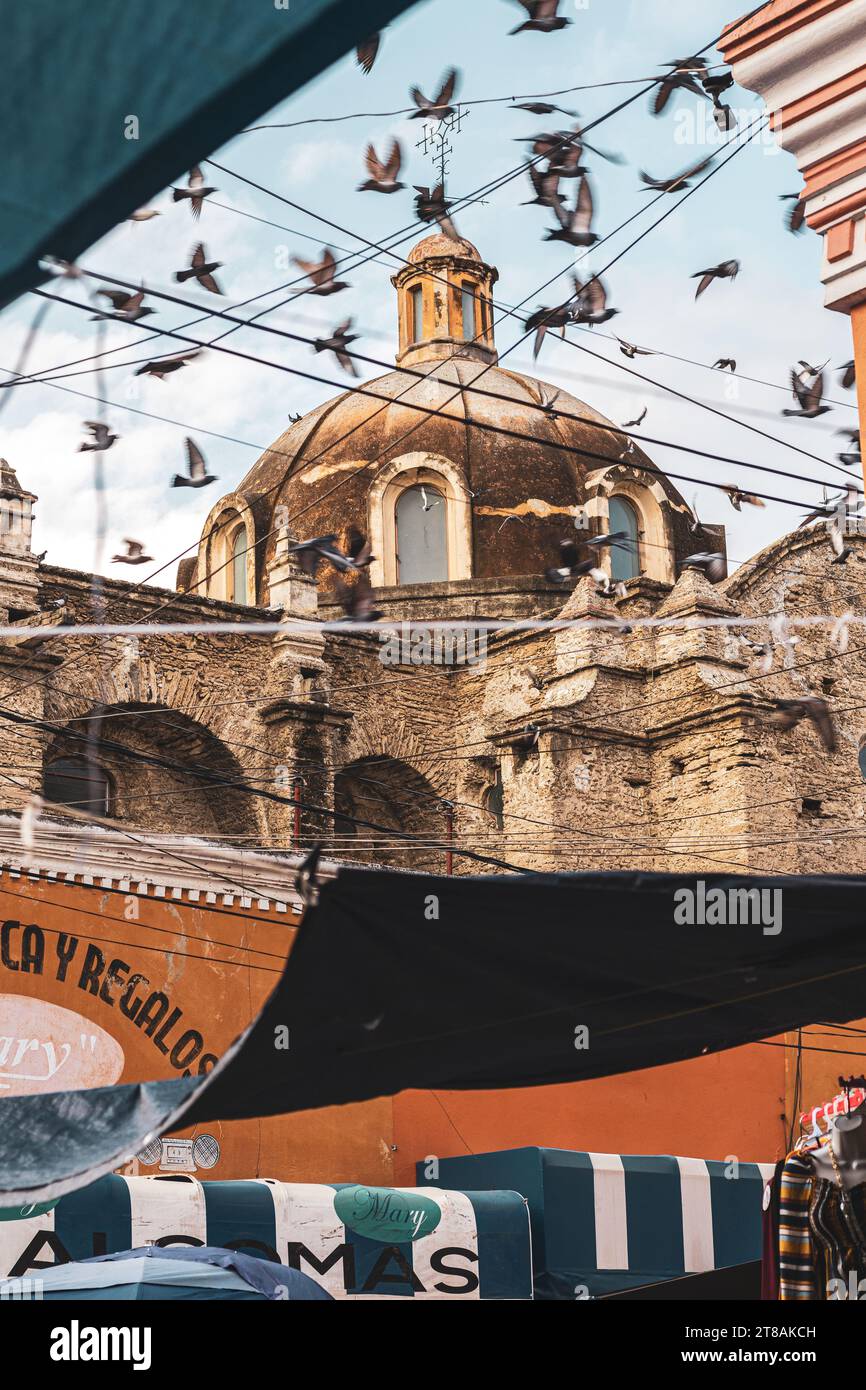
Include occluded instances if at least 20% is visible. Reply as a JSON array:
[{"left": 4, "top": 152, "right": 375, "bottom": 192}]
[{"left": 200, "top": 234, "right": 723, "bottom": 603}]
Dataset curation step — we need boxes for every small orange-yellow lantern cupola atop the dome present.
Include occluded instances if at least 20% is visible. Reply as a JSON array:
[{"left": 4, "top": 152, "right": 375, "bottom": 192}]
[{"left": 392, "top": 232, "right": 499, "bottom": 367}]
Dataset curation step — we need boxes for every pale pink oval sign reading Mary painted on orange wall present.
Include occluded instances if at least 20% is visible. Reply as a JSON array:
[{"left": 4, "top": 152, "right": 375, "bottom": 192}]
[{"left": 0, "top": 994, "right": 124, "bottom": 1098}]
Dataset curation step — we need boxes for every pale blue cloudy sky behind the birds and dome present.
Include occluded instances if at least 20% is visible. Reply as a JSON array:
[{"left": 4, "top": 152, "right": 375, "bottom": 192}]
[{"left": 0, "top": 0, "right": 856, "bottom": 582}]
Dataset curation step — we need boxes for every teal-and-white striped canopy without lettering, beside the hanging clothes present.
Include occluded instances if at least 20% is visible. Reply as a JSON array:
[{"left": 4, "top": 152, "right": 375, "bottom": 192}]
[{"left": 418, "top": 1148, "right": 773, "bottom": 1300}]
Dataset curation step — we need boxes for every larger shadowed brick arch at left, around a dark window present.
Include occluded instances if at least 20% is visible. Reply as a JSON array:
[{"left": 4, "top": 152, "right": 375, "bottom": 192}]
[{"left": 43, "top": 701, "right": 265, "bottom": 844}]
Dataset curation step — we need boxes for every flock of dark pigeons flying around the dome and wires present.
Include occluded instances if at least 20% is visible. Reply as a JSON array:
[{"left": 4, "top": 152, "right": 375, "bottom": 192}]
[{"left": 28, "top": 0, "right": 863, "bottom": 751}]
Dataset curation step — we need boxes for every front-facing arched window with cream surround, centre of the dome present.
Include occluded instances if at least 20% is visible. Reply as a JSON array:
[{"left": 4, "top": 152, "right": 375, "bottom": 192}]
[{"left": 368, "top": 453, "right": 473, "bottom": 587}]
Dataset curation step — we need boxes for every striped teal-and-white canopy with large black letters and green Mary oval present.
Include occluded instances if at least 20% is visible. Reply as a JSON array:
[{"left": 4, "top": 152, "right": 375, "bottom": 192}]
[{"left": 0, "top": 1175, "right": 532, "bottom": 1301}]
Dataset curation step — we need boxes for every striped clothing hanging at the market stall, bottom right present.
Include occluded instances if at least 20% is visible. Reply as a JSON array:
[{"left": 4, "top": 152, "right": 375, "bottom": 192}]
[{"left": 778, "top": 1152, "right": 866, "bottom": 1301}]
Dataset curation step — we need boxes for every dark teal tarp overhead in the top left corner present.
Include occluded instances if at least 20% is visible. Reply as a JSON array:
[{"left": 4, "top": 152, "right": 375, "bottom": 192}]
[{"left": 0, "top": 0, "right": 416, "bottom": 307}]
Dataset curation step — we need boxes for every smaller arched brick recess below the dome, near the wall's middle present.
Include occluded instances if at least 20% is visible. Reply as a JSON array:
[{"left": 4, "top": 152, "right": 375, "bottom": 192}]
[{"left": 334, "top": 756, "right": 446, "bottom": 873}]
